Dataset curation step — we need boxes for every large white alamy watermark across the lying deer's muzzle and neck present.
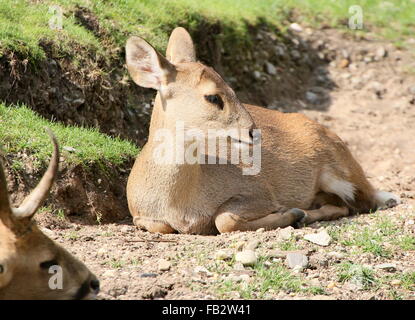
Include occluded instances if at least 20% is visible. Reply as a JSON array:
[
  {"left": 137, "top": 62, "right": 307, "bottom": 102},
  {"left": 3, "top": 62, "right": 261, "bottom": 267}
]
[{"left": 153, "top": 121, "right": 261, "bottom": 175}]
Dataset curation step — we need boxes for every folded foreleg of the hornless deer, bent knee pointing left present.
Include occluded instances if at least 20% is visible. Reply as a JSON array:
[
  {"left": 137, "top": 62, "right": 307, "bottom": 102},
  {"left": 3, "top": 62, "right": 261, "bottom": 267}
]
[{"left": 215, "top": 209, "right": 305, "bottom": 233}]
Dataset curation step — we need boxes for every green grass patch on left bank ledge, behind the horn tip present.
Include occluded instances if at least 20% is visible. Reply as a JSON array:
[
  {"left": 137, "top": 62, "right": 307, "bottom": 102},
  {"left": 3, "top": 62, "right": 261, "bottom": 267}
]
[{"left": 0, "top": 103, "right": 138, "bottom": 169}]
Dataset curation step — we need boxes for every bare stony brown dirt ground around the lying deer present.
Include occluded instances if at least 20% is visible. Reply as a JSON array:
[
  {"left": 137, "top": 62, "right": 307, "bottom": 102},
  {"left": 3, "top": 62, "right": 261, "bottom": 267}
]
[{"left": 36, "top": 29, "right": 415, "bottom": 299}]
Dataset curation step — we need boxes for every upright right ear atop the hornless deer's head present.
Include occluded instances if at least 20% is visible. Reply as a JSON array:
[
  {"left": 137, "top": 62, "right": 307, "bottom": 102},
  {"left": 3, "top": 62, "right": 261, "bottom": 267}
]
[{"left": 166, "top": 27, "right": 196, "bottom": 64}]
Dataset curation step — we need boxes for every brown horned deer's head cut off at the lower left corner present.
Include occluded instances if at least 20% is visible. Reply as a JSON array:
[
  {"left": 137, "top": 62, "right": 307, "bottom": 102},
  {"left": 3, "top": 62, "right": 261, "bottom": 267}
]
[{"left": 0, "top": 133, "right": 99, "bottom": 300}]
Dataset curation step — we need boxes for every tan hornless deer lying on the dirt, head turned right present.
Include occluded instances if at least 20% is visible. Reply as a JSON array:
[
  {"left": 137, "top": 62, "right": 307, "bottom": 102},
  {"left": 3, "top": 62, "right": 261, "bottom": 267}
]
[{"left": 126, "top": 28, "right": 400, "bottom": 234}]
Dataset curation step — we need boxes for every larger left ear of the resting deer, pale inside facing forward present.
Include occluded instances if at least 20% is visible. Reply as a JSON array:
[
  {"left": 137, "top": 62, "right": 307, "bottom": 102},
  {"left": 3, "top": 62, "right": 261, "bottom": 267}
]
[{"left": 125, "top": 37, "right": 175, "bottom": 90}]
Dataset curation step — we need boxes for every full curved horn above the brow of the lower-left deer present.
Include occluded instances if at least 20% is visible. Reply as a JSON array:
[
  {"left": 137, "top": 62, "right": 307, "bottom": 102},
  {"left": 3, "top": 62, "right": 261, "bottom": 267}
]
[{"left": 11, "top": 128, "right": 59, "bottom": 219}]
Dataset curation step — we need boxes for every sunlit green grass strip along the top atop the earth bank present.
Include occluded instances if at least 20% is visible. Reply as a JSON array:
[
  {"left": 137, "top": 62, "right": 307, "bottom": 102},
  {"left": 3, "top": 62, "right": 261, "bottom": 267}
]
[{"left": 0, "top": 0, "right": 415, "bottom": 62}]
